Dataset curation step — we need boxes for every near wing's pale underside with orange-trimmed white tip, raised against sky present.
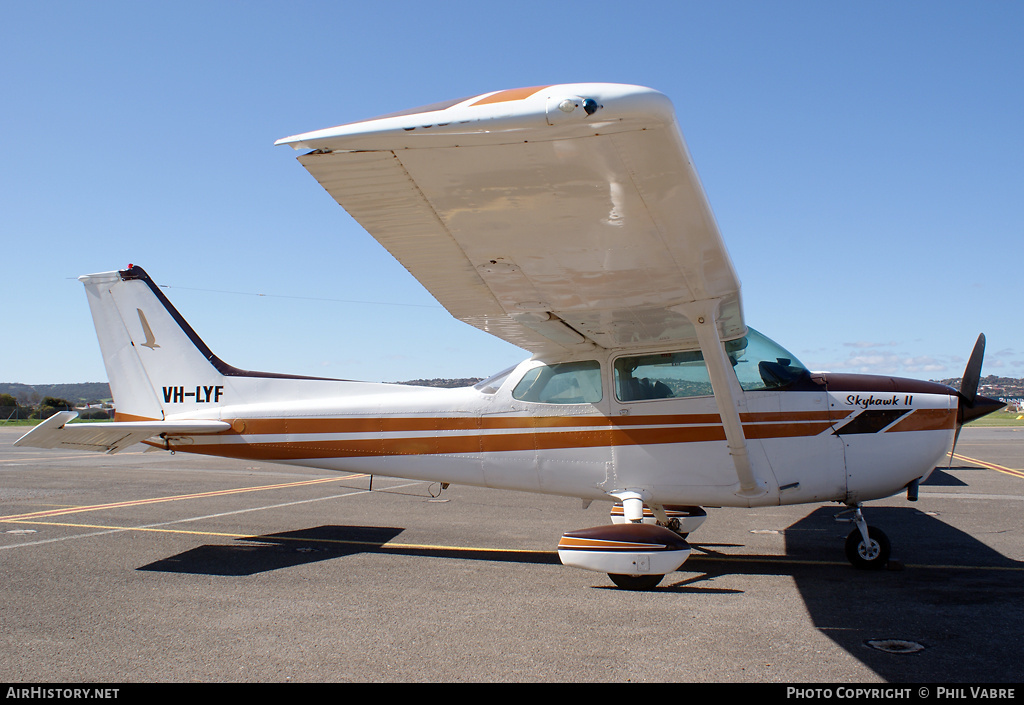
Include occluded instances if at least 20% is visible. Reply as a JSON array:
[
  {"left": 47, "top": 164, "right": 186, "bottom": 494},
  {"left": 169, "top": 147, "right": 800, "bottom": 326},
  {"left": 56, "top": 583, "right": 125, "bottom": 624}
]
[{"left": 276, "top": 83, "right": 746, "bottom": 355}]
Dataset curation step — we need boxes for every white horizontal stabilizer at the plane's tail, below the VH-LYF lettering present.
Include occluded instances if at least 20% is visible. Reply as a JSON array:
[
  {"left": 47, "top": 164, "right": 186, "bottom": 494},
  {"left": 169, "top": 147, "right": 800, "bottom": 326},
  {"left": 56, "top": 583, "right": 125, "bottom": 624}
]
[{"left": 14, "top": 411, "right": 231, "bottom": 453}]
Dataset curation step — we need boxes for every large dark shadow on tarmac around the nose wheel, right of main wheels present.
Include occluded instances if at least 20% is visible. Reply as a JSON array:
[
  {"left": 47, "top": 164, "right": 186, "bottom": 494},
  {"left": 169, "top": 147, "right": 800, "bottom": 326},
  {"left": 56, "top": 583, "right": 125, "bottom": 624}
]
[{"left": 662, "top": 471, "right": 1024, "bottom": 683}]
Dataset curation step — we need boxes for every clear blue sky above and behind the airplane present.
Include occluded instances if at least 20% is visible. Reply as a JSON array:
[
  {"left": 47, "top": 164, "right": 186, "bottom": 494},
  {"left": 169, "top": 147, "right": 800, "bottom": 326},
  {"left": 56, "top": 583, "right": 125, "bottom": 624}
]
[{"left": 0, "top": 0, "right": 1024, "bottom": 383}]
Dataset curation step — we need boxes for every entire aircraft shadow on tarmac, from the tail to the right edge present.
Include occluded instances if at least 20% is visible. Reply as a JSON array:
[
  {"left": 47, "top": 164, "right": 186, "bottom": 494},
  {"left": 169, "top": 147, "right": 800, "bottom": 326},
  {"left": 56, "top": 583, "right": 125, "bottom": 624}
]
[{"left": 138, "top": 471, "right": 1024, "bottom": 682}]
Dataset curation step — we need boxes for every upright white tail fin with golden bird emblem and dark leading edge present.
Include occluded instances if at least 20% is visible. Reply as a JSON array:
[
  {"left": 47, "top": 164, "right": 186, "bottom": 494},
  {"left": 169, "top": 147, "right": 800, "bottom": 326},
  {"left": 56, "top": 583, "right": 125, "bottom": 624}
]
[{"left": 79, "top": 265, "right": 231, "bottom": 420}]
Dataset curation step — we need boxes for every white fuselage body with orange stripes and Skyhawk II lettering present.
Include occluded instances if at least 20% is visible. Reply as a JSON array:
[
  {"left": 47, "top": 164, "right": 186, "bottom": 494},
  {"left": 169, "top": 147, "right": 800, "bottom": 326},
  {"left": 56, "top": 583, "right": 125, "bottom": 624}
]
[{"left": 163, "top": 352, "right": 956, "bottom": 506}]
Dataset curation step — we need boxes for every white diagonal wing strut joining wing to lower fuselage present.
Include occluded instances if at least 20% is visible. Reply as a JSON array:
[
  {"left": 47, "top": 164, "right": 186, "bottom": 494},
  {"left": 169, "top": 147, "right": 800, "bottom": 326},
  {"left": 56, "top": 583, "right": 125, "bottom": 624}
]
[{"left": 673, "top": 298, "right": 768, "bottom": 497}]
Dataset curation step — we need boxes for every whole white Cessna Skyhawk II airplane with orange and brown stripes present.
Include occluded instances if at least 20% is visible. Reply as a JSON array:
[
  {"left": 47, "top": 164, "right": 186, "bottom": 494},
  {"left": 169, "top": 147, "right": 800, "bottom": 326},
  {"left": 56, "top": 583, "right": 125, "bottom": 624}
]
[{"left": 17, "top": 84, "right": 1001, "bottom": 588}]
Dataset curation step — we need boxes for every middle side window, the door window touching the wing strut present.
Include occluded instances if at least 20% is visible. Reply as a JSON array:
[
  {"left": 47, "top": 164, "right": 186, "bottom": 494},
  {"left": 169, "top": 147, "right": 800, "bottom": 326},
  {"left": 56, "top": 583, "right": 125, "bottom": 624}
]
[{"left": 614, "top": 350, "right": 715, "bottom": 402}]
